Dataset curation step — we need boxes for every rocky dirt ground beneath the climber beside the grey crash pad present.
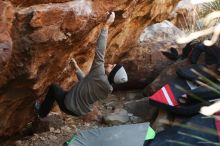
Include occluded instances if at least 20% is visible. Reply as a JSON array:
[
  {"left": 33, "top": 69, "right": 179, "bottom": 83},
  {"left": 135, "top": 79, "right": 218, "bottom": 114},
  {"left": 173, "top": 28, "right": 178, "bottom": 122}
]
[{"left": 0, "top": 91, "right": 151, "bottom": 146}]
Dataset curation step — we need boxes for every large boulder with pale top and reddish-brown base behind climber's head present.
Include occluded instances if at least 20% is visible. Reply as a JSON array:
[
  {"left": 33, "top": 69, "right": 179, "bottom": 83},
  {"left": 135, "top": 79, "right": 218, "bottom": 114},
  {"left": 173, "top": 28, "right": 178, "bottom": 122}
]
[{"left": 117, "top": 20, "right": 184, "bottom": 88}]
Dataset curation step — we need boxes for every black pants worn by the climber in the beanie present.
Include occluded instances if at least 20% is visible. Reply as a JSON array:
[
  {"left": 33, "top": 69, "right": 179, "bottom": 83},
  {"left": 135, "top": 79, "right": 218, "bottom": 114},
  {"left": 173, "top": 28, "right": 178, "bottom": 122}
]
[{"left": 38, "top": 85, "right": 76, "bottom": 118}]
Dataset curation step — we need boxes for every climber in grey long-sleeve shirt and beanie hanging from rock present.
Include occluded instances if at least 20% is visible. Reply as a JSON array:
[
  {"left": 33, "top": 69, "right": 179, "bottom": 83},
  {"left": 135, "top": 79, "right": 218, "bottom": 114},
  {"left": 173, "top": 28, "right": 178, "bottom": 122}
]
[{"left": 35, "top": 12, "right": 128, "bottom": 117}]
